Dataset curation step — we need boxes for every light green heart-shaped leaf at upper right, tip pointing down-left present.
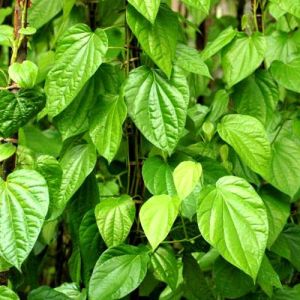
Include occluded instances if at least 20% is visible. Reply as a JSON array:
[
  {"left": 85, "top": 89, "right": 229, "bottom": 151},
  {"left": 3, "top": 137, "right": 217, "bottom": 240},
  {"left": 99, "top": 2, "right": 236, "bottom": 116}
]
[{"left": 222, "top": 32, "right": 266, "bottom": 87}]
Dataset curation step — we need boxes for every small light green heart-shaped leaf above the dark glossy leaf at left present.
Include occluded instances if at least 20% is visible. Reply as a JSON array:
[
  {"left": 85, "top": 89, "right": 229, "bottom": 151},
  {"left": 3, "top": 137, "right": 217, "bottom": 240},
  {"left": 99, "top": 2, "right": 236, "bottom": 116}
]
[{"left": 8, "top": 60, "right": 38, "bottom": 88}]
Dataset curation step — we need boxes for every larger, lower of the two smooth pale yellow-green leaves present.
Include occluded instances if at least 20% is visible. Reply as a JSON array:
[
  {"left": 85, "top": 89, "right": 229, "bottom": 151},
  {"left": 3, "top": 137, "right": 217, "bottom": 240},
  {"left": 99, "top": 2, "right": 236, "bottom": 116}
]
[{"left": 140, "top": 195, "right": 180, "bottom": 249}]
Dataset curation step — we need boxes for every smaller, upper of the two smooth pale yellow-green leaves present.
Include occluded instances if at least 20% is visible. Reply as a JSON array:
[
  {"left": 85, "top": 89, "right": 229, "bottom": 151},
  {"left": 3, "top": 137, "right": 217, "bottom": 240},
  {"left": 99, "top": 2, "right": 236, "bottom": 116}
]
[{"left": 173, "top": 161, "right": 202, "bottom": 200}]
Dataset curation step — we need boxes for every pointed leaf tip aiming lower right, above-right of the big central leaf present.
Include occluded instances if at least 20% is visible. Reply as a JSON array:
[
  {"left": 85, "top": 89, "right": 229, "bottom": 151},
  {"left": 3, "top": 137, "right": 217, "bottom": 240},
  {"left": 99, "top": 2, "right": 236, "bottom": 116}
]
[{"left": 175, "top": 44, "right": 212, "bottom": 78}]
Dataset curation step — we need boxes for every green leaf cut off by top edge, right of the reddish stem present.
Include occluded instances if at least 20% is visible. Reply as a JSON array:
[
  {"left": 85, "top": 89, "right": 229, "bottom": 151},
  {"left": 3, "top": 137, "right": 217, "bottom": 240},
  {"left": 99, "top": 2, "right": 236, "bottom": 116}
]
[{"left": 28, "top": 0, "right": 62, "bottom": 29}]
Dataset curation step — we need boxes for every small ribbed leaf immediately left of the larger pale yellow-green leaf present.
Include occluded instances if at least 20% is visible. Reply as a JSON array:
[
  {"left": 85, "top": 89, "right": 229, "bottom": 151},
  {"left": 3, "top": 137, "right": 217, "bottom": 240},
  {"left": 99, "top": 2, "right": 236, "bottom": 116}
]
[{"left": 95, "top": 195, "right": 135, "bottom": 247}]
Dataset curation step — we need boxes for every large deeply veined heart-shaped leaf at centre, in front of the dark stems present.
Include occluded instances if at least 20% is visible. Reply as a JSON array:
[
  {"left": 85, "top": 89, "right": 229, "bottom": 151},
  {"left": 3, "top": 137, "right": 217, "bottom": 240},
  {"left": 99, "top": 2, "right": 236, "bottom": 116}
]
[{"left": 125, "top": 66, "right": 189, "bottom": 153}]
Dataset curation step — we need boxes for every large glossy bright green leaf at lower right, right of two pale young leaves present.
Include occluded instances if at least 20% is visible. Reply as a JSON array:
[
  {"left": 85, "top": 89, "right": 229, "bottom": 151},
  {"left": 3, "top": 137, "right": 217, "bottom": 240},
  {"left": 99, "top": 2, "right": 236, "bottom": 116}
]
[{"left": 197, "top": 176, "right": 269, "bottom": 280}]
